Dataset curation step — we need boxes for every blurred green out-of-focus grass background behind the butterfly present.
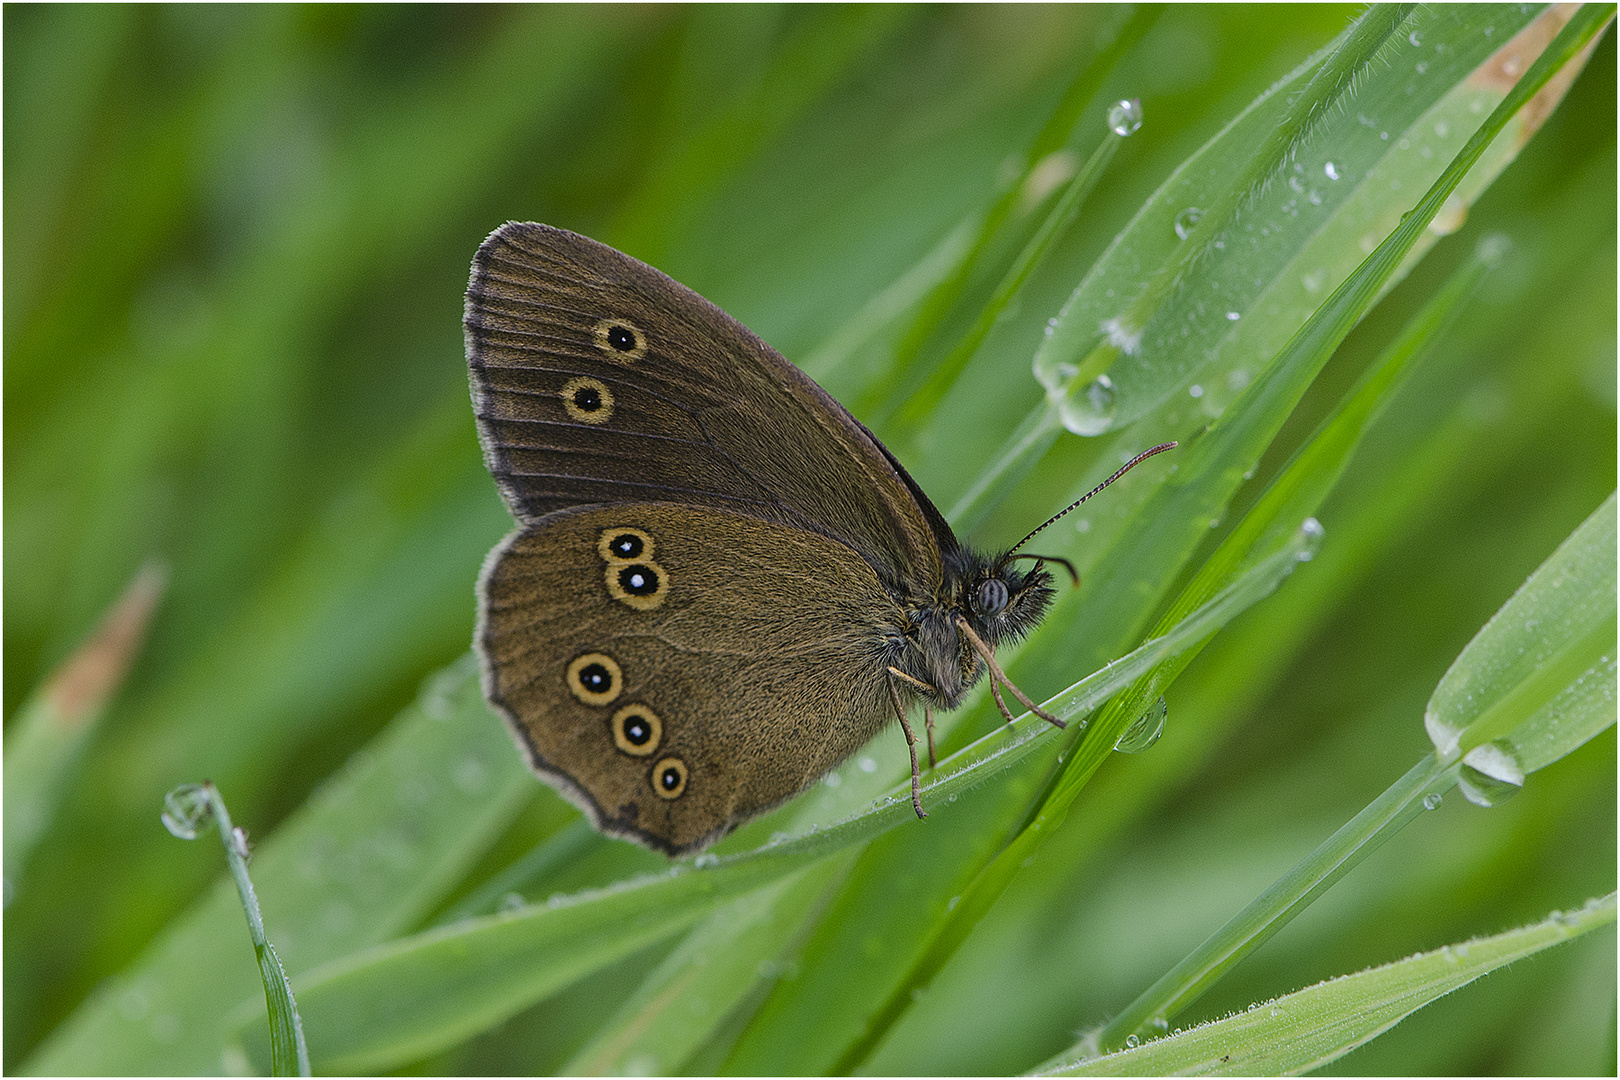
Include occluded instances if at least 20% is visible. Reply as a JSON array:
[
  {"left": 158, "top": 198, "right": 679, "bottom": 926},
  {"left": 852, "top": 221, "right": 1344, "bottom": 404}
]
[{"left": 3, "top": 5, "right": 1615, "bottom": 1072}]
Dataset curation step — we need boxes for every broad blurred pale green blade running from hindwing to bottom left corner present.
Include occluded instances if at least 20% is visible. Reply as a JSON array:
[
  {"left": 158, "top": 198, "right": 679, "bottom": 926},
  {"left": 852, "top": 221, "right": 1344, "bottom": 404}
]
[{"left": 21, "top": 657, "right": 535, "bottom": 1075}]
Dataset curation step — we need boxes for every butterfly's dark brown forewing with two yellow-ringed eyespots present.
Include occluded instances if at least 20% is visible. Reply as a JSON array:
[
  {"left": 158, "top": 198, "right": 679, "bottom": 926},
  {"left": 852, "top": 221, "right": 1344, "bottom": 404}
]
[{"left": 465, "top": 223, "right": 954, "bottom": 593}]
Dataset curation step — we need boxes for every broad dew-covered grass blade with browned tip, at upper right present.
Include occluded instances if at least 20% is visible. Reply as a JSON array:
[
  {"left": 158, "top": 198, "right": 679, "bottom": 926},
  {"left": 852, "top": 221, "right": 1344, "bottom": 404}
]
[{"left": 953, "top": 8, "right": 1557, "bottom": 526}]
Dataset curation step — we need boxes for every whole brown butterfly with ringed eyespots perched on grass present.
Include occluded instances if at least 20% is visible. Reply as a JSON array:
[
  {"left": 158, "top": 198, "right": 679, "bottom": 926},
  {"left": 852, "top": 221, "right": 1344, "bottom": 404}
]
[{"left": 465, "top": 223, "right": 1175, "bottom": 855}]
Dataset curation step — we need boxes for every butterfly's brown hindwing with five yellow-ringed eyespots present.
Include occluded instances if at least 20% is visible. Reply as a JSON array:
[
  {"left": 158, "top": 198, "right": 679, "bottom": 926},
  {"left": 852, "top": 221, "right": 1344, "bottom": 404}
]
[{"left": 478, "top": 504, "right": 901, "bottom": 853}]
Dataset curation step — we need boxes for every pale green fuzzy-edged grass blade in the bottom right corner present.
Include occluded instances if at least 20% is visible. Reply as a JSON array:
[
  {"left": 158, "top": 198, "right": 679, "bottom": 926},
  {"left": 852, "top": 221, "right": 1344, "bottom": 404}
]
[{"left": 1038, "top": 892, "right": 1615, "bottom": 1077}]
